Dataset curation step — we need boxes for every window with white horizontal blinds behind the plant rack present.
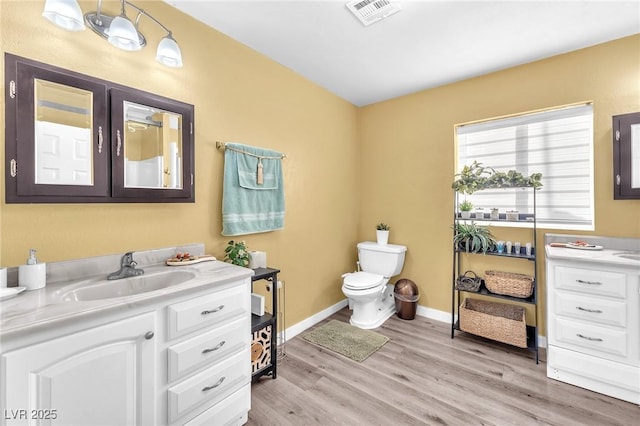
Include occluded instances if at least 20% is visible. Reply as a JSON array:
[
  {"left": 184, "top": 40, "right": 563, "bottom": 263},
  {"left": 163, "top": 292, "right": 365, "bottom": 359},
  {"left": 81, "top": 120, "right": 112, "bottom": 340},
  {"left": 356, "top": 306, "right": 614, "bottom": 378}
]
[{"left": 456, "top": 104, "right": 594, "bottom": 230}]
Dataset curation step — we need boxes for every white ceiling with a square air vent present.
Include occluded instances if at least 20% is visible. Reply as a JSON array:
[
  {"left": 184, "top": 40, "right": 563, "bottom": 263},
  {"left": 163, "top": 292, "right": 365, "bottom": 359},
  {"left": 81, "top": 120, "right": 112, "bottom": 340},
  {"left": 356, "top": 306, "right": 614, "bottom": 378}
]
[{"left": 165, "top": 0, "right": 640, "bottom": 106}]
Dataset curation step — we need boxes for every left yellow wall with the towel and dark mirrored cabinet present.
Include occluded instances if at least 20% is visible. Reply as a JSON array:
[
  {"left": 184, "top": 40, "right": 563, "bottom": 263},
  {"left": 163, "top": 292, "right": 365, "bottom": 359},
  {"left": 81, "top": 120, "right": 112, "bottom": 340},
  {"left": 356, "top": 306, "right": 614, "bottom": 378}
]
[{"left": 0, "top": 1, "right": 360, "bottom": 324}]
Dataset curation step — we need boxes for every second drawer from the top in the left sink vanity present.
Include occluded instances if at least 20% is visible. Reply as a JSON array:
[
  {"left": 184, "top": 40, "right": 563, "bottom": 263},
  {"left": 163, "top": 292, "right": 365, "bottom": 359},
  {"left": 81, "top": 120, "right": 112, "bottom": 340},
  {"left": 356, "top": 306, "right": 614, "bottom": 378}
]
[{"left": 167, "top": 316, "right": 251, "bottom": 381}]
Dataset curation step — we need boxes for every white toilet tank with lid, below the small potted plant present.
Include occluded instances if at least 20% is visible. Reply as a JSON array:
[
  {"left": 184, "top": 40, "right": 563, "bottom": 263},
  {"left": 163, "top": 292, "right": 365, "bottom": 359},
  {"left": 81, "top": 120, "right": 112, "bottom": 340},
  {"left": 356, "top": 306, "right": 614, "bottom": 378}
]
[{"left": 358, "top": 241, "right": 407, "bottom": 278}]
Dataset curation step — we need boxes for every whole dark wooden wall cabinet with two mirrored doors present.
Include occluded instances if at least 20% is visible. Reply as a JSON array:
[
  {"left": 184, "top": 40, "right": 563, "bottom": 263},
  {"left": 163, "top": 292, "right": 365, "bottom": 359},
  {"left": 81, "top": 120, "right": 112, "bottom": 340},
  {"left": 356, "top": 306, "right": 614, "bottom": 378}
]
[{"left": 5, "top": 53, "right": 194, "bottom": 203}]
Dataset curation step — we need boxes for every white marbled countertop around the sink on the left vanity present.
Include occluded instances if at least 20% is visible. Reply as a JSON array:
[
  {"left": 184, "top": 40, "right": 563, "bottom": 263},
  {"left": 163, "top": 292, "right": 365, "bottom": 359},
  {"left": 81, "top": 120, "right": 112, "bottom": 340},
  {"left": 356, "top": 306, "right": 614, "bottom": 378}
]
[{"left": 0, "top": 261, "right": 253, "bottom": 337}]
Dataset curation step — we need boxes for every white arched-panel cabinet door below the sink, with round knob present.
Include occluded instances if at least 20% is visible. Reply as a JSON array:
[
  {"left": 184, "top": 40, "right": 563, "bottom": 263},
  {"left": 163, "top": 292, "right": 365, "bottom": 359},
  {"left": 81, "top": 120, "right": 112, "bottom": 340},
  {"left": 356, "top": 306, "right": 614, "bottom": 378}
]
[{"left": 2, "top": 313, "right": 156, "bottom": 426}]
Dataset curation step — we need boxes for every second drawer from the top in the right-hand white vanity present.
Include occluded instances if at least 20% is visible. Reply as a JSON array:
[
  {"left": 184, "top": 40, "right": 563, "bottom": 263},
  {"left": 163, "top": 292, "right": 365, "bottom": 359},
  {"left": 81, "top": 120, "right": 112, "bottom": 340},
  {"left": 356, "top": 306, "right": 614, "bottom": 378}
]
[{"left": 554, "top": 291, "right": 627, "bottom": 327}]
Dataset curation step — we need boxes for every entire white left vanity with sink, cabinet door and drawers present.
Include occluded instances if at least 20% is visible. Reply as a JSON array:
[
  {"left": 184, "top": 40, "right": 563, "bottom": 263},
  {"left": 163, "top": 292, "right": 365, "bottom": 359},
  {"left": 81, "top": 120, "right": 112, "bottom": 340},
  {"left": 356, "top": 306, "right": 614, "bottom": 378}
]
[{"left": 0, "top": 245, "right": 253, "bottom": 425}]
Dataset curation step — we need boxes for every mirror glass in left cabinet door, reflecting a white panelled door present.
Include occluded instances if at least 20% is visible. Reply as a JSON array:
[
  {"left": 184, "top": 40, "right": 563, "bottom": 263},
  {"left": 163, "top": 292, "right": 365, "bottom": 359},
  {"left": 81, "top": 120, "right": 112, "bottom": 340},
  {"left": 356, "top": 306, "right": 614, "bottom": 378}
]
[{"left": 34, "top": 78, "right": 94, "bottom": 186}]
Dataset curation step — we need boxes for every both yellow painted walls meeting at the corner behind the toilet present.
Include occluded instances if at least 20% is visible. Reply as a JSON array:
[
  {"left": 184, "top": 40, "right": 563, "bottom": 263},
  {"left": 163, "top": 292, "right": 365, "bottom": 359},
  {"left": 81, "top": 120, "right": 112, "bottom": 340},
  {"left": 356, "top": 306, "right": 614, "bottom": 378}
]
[{"left": 0, "top": 1, "right": 640, "bottom": 332}]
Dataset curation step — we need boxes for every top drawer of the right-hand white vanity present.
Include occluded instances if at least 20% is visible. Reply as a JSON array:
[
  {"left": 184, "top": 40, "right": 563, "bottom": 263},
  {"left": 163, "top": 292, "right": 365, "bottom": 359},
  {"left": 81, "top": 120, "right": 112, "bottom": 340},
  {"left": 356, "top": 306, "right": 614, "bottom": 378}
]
[{"left": 555, "top": 266, "right": 627, "bottom": 299}]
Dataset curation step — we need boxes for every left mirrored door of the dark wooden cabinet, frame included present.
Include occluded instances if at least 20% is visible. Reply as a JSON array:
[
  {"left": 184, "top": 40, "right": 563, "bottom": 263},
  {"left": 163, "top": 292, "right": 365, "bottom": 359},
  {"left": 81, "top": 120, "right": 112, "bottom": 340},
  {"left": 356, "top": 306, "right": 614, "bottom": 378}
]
[{"left": 5, "top": 55, "right": 111, "bottom": 203}]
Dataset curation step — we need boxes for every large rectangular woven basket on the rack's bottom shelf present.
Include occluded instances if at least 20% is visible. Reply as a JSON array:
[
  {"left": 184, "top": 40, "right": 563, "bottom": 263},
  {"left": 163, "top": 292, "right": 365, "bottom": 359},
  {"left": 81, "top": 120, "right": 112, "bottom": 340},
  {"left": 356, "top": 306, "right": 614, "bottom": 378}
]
[{"left": 459, "top": 297, "right": 527, "bottom": 348}]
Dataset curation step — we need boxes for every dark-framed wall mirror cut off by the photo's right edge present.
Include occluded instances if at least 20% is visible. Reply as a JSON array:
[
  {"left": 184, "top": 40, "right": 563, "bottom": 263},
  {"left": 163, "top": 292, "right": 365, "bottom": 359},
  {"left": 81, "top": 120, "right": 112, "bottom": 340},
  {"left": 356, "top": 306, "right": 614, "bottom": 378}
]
[{"left": 613, "top": 112, "right": 640, "bottom": 200}]
